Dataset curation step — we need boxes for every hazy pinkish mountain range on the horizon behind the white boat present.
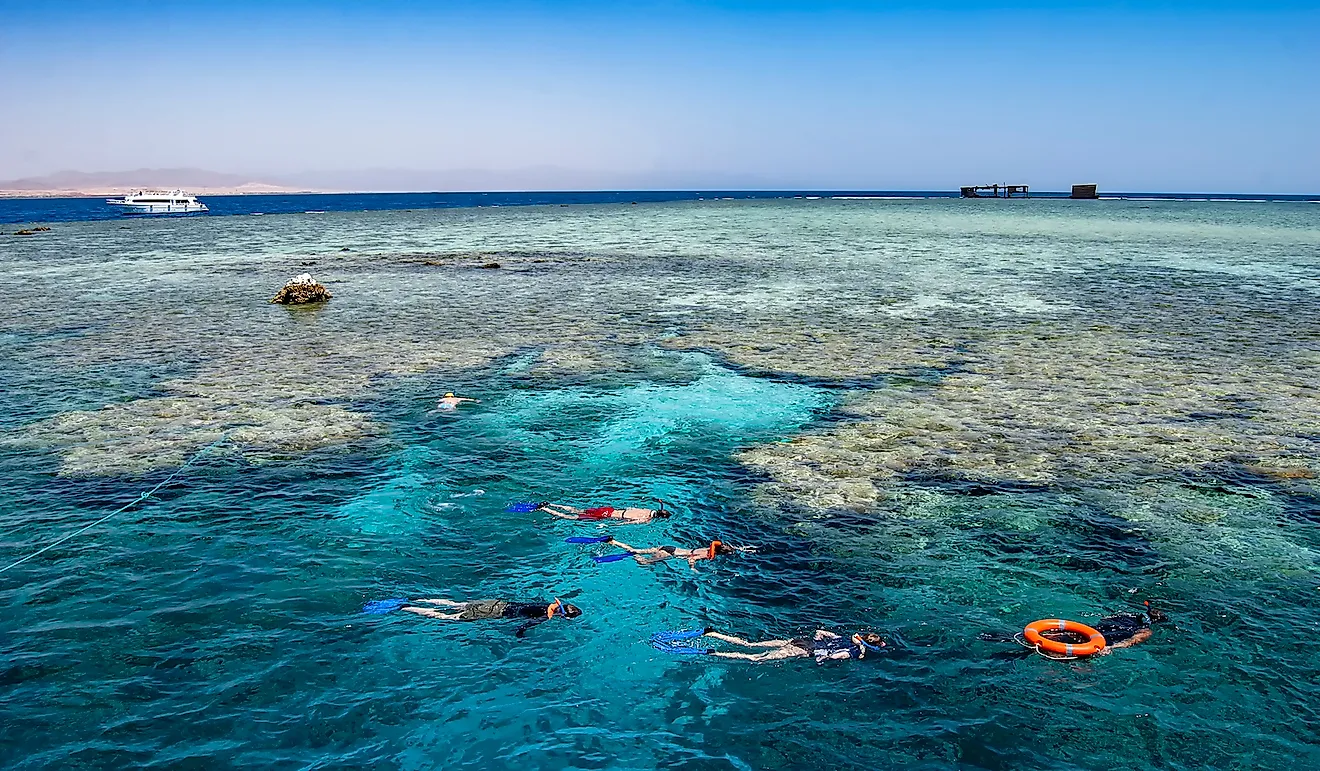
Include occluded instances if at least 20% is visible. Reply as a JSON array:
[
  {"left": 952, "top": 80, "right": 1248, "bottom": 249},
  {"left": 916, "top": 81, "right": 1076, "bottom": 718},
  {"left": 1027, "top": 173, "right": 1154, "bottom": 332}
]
[{"left": 0, "top": 166, "right": 771, "bottom": 197}]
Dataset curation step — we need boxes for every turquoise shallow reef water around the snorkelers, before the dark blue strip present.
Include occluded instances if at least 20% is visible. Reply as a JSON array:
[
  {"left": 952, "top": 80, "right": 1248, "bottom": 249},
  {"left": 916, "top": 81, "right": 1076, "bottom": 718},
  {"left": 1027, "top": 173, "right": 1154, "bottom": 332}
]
[{"left": 0, "top": 201, "right": 1320, "bottom": 768}]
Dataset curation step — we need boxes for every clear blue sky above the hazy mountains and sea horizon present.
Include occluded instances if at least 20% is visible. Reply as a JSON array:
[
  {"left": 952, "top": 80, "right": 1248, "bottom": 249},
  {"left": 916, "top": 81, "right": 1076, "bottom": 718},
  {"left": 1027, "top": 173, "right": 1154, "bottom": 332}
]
[{"left": 0, "top": 0, "right": 1320, "bottom": 193}]
